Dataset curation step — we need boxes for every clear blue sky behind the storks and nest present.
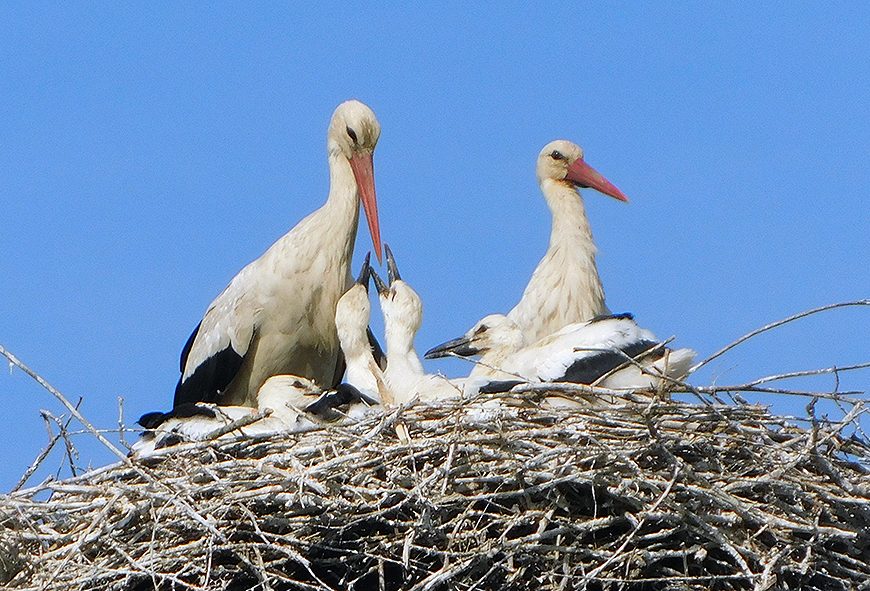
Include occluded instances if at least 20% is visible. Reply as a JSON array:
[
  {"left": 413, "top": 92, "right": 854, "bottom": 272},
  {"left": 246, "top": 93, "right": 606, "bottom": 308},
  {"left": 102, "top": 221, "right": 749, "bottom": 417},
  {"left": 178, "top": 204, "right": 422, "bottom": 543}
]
[{"left": 0, "top": 2, "right": 870, "bottom": 490}]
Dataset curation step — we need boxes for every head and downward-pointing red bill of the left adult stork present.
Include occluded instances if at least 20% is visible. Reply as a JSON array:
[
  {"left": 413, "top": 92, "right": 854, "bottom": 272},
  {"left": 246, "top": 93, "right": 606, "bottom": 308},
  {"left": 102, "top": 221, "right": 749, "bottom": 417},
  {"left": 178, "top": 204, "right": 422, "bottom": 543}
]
[{"left": 327, "top": 100, "right": 381, "bottom": 261}]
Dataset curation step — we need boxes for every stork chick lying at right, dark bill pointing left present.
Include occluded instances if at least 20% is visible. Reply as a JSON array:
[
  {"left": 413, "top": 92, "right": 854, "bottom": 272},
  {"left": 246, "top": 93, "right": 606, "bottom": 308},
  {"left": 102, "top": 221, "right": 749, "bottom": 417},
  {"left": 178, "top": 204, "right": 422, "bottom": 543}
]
[{"left": 426, "top": 314, "right": 695, "bottom": 390}]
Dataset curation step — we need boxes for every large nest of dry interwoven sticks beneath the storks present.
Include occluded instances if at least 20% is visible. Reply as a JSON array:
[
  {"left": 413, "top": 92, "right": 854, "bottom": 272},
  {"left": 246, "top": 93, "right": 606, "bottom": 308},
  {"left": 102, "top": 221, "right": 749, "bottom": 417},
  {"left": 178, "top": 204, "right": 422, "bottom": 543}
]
[{"left": 0, "top": 393, "right": 870, "bottom": 591}]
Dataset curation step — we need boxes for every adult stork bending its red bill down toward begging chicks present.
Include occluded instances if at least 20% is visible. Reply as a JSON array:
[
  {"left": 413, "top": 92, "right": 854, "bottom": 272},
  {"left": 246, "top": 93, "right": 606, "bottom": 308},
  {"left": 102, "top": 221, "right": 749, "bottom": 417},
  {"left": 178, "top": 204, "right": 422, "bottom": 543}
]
[{"left": 174, "top": 100, "right": 381, "bottom": 407}]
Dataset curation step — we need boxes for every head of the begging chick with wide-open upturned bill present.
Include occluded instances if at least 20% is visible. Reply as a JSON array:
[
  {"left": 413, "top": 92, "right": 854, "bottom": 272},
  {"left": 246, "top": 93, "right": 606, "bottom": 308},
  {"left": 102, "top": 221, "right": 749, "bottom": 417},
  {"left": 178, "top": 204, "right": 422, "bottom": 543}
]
[{"left": 372, "top": 245, "right": 423, "bottom": 351}]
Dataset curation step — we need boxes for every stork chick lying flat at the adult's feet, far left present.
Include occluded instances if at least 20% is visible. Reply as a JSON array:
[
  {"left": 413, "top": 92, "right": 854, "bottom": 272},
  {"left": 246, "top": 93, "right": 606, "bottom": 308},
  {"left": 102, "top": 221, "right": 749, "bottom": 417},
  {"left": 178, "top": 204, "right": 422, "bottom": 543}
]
[{"left": 131, "top": 375, "right": 374, "bottom": 457}]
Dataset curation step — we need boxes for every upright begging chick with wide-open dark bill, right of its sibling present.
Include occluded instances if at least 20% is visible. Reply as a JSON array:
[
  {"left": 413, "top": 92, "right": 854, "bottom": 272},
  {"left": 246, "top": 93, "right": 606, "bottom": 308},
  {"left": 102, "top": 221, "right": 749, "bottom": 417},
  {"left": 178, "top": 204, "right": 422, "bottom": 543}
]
[{"left": 371, "top": 245, "right": 469, "bottom": 404}]
